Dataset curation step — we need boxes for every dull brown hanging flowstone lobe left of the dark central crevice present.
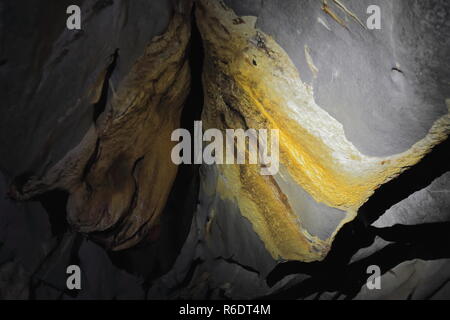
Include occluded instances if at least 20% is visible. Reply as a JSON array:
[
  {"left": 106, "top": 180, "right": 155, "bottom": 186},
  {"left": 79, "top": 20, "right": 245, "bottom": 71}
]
[{"left": 10, "top": 9, "right": 191, "bottom": 250}]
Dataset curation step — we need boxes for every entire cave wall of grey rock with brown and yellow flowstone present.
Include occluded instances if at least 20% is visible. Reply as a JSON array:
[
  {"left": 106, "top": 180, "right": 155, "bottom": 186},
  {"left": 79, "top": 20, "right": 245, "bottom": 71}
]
[{"left": 0, "top": 0, "right": 450, "bottom": 299}]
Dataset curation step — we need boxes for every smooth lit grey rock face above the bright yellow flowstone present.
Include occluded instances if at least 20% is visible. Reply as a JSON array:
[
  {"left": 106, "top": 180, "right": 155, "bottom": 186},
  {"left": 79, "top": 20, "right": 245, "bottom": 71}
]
[{"left": 225, "top": 0, "right": 450, "bottom": 156}]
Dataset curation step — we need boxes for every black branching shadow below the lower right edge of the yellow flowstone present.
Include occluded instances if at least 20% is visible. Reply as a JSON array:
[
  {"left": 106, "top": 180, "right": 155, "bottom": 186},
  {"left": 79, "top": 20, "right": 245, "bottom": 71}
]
[{"left": 262, "top": 139, "right": 450, "bottom": 299}]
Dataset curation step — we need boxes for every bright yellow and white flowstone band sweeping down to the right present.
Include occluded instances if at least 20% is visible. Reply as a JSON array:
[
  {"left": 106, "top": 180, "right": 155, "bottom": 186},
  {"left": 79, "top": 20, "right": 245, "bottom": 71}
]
[{"left": 196, "top": 0, "right": 450, "bottom": 261}]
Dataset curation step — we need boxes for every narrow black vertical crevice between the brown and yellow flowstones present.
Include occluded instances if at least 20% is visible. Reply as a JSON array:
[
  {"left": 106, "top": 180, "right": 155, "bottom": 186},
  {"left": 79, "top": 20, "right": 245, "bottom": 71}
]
[{"left": 109, "top": 8, "right": 204, "bottom": 286}]
